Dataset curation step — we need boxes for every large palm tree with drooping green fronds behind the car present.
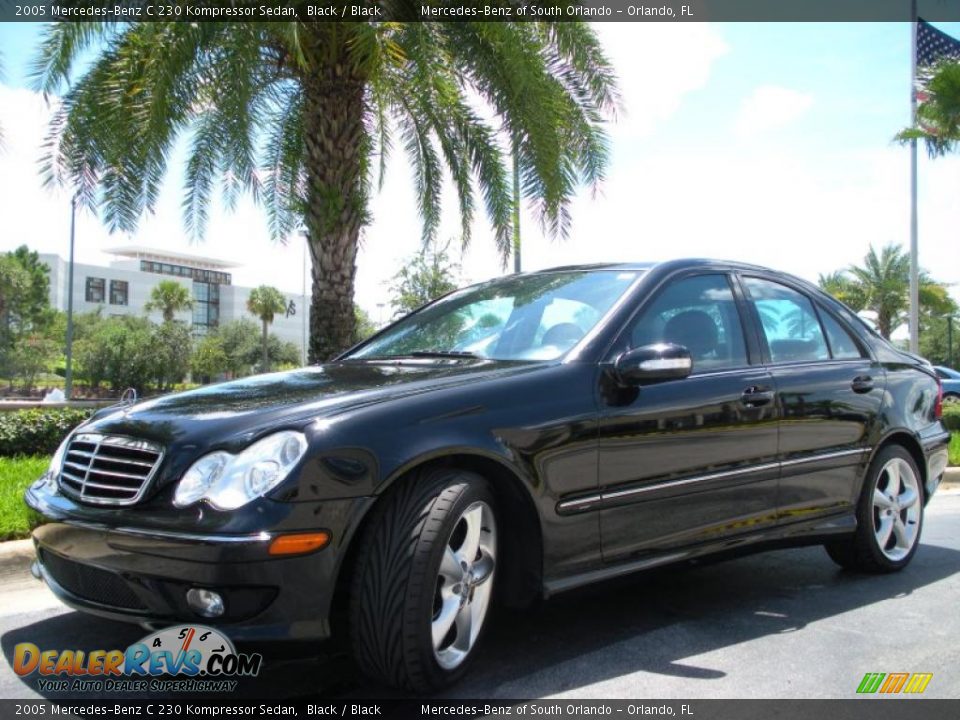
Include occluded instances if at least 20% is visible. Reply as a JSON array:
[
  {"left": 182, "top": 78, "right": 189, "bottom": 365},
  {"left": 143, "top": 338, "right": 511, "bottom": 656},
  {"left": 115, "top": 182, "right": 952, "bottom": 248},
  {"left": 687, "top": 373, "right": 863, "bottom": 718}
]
[{"left": 34, "top": 21, "right": 618, "bottom": 361}]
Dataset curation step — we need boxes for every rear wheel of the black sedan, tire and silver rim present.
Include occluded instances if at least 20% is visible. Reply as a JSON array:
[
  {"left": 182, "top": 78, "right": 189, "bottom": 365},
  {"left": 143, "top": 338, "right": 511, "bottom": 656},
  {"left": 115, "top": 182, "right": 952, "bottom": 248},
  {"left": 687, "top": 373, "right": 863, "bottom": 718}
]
[{"left": 825, "top": 445, "right": 924, "bottom": 573}]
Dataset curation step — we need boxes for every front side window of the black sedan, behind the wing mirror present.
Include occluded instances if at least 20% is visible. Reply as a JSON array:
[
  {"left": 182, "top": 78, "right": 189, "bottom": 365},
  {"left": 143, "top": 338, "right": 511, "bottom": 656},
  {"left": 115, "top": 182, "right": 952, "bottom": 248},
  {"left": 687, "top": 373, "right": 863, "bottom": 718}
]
[{"left": 628, "top": 275, "right": 748, "bottom": 372}]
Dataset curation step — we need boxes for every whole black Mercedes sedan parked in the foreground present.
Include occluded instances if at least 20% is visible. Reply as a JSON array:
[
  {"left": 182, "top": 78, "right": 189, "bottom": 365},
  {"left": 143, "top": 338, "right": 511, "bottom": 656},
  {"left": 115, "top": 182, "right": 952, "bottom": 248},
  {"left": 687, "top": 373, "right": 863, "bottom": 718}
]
[{"left": 27, "top": 260, "right": 948, "bottom": 691}]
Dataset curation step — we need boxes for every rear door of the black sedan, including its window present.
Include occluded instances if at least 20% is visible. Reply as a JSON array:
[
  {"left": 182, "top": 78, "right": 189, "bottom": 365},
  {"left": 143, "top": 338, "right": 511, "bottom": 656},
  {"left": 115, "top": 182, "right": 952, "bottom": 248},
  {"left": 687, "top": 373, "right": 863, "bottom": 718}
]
[{"left": 742, "top": 275, "right": 884, "bottom": 523}]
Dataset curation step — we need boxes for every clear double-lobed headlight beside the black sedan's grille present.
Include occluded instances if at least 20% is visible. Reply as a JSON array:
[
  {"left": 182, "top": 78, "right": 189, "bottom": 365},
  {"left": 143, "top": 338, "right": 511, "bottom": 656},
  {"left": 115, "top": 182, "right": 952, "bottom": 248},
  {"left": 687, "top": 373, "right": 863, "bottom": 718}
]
[{"left": 173, "top": 430, "right": 307, "bottom": 510}]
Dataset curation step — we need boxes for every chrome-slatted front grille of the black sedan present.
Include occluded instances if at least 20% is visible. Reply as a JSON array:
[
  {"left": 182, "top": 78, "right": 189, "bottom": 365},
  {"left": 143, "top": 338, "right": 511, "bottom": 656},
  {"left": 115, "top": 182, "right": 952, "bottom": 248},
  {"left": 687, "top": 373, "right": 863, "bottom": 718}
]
[{"left": 60, "top": 433, "right": 163, "bottom": 505}]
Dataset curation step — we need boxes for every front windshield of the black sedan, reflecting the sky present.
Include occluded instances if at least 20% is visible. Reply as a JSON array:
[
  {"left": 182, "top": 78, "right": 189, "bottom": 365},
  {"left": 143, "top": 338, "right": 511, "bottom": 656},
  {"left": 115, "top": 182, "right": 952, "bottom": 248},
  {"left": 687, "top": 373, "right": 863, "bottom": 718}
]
[{"left": 348, "top": 270, "right": 640, "bottom": 360}]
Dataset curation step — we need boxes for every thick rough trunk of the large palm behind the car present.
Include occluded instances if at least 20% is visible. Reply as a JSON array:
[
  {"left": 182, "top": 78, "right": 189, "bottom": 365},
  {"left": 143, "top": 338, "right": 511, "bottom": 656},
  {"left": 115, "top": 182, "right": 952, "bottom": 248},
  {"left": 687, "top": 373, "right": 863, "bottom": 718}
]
[{"left": 303, "top": 59, "right": 366, "bottom": 362}]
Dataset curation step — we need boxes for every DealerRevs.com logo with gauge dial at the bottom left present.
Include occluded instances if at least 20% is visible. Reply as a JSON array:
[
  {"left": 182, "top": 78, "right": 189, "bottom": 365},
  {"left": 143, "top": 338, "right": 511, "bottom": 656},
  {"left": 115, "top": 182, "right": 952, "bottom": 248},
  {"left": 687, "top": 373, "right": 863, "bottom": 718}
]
[{"left": 13, "top": 625, "right": 263, "bottom": 692}]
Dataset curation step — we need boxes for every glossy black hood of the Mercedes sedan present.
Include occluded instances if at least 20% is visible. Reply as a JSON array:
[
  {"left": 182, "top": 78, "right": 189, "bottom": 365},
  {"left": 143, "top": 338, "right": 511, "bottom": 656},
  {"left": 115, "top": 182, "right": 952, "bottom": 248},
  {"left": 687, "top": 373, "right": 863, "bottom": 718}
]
[{"left": 83, "top": 359, "right": 536, "bottom": 448}]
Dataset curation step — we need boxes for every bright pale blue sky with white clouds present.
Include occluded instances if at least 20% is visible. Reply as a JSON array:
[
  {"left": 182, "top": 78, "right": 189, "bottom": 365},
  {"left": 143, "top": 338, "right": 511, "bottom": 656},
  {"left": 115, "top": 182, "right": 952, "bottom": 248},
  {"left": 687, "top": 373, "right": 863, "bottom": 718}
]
[{"left": 0, "top": 23, "right": 960, "bottom": 324}]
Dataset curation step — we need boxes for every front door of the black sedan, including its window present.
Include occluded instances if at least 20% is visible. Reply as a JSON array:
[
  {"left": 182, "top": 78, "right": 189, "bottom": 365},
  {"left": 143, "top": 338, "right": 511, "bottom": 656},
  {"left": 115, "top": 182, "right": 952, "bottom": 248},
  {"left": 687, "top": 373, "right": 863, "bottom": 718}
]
[{"left": 599, "top": 272, "right": 778, "bottom": 561}]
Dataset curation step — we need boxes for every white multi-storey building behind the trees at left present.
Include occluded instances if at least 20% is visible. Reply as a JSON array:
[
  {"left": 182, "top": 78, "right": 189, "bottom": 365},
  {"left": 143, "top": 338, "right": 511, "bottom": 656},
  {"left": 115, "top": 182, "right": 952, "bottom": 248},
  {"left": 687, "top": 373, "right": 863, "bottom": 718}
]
[{"left": 40, "top": 246, "right": 310, "bottom": 355}]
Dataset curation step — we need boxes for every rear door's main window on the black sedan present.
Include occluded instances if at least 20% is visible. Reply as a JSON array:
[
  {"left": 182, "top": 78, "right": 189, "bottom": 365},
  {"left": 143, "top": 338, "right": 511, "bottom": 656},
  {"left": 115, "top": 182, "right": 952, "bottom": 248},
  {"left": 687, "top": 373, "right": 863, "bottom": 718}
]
[{"left": 744, "top": 277, "right": 830, "bottom": 363}]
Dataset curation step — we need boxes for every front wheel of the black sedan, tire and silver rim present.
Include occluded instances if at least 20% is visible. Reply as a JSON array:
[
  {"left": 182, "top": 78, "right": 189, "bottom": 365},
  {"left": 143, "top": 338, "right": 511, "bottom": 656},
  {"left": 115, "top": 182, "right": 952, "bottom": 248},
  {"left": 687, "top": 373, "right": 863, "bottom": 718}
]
[{"left": 350, "top": 468, "right": 497, "bottom": 693}]
